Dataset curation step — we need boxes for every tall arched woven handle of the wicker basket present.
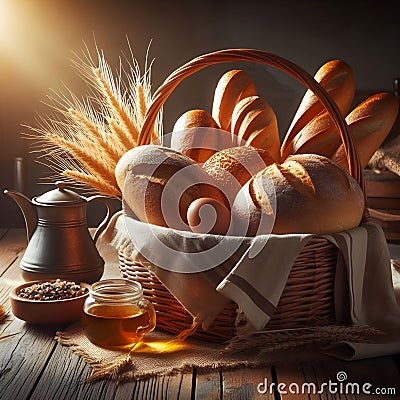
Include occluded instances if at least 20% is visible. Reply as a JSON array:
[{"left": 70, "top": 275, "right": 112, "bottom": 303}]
[{"left": 138, "top": 48, "right": 365, "bottom": 212}]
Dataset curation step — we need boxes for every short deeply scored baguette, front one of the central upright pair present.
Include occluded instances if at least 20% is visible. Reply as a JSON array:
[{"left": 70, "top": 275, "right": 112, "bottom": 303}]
[{"left": 231, "top": 96, "right": 280, "bottom": 161}]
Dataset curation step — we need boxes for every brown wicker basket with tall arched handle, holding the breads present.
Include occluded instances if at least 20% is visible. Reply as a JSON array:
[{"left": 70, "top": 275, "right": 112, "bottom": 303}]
[{"left": 120, "top": 49, "right": 368, "bottom": 342}]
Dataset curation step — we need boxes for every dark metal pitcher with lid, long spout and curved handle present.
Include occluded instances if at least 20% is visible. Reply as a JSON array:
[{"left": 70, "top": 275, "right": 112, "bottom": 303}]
[{"left": 4, "top": 181, "right": 112, "bottom": 283}]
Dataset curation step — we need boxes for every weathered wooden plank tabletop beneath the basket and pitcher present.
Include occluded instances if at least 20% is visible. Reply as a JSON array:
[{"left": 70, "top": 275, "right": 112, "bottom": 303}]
[{"left": 0, "top": 229, "right": 400, "bottom": 400}]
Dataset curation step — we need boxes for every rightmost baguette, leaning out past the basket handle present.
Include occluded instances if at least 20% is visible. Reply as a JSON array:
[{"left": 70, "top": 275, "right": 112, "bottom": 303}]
[{"left": 332, "top": 93, "right": 399, "bottom": 169}]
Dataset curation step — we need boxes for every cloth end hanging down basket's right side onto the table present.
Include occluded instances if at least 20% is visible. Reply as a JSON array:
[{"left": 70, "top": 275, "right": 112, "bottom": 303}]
[{"left": 325, "top": 224, "right": 400, "bottom": 360}]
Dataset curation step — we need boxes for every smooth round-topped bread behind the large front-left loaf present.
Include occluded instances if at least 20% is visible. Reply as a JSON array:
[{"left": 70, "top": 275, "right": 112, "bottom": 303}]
[{"left": 171, "top": 110, "right": 234, "bottom": 163}]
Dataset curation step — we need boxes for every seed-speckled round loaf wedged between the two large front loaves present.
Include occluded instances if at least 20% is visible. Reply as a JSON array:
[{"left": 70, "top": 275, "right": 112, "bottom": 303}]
[{"left": 203, "top": 146, "right": 275, "bottom": 202}]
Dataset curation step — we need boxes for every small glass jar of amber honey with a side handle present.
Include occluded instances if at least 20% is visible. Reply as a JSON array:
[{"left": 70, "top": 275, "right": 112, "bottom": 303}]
[{"left": 83, "top": 279, "right": 156, "bottom": 350}]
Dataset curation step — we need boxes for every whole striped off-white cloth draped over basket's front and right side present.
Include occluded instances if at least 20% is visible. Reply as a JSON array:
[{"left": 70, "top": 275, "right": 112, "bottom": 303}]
[{"left": 103, "top": 213, "right": 400, "bottom": 359}]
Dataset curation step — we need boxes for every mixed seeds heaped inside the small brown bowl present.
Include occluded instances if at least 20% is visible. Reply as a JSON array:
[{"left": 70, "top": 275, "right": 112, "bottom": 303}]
[{"left": 17, "top": 279, "right": 89, "bottom": 301}]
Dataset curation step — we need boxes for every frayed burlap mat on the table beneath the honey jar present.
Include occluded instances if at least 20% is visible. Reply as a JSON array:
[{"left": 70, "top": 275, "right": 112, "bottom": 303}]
[{"left": 56, "top": 324, "right": 261, "bottom": 381}]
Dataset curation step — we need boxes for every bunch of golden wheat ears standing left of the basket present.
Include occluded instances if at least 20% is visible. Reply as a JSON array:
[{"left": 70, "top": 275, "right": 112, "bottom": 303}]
[{"left": 25, "top": 42, "right": 162, "bottom": 198}]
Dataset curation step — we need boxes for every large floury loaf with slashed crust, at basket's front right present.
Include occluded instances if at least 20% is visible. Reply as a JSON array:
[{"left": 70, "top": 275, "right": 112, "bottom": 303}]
[{"left": 232, "top": 154, "right": 364, "bottom": 236}]
